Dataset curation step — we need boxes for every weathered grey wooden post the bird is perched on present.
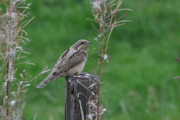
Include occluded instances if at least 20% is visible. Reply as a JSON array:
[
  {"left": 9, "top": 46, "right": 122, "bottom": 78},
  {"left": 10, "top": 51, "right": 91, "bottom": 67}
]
[{"left": 64, "top": 73, "right": 98, "bottom": 120}]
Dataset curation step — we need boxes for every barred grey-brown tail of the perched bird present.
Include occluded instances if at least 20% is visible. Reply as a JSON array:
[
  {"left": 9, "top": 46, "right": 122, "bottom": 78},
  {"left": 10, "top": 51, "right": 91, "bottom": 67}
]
[{"left": 36, "top": 73, "right": 59, "bottom": 88}]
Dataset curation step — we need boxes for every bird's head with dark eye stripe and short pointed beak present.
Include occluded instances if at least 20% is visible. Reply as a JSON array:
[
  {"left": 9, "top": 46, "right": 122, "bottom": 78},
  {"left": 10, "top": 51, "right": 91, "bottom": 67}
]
[{"left": 72, "top": 39, "right": 92, "bottom": 51}]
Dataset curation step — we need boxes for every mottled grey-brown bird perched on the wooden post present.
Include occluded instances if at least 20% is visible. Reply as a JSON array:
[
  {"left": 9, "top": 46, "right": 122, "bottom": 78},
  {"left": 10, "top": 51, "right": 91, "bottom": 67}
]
[{"left": 36, "top": 39, "right": 92, "bottom": 88}]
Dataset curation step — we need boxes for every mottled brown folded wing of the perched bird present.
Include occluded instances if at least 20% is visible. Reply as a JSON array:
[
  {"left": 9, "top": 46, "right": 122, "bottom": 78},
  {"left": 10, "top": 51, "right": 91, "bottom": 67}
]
[{"left": 53, "top": 51, "right": 87, "bottom": 75}]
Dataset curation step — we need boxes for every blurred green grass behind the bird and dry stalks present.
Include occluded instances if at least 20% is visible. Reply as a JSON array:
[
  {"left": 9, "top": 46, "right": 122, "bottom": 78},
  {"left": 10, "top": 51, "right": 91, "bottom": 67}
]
[{"left": 5, "top": 0, "right": 180, "bottom": 120}]
